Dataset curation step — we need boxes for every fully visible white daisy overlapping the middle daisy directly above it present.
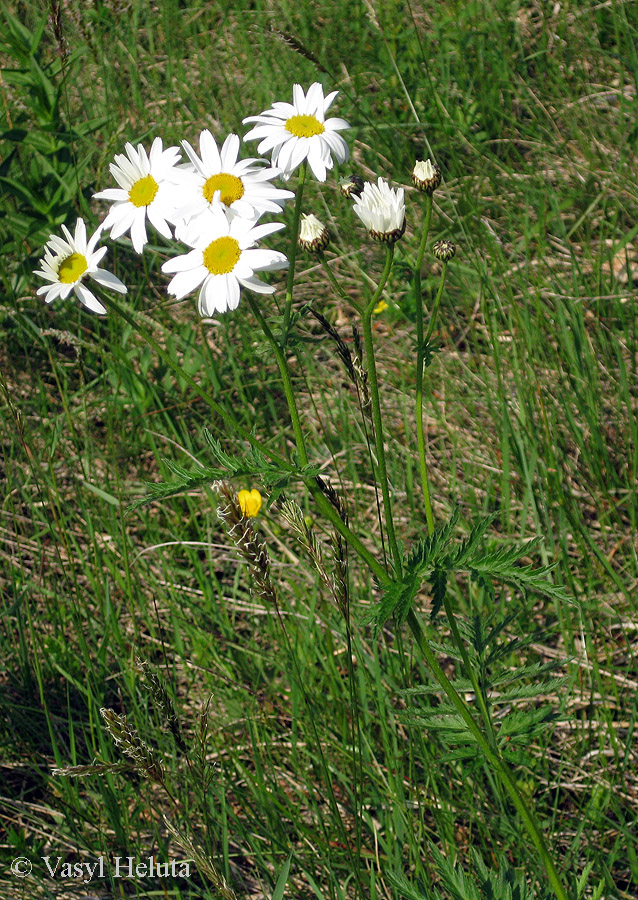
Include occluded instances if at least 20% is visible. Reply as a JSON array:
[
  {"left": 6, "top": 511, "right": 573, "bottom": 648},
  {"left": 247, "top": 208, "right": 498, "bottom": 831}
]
[{"left": 162, "top": 204, "right": 288, "bottom": 316}]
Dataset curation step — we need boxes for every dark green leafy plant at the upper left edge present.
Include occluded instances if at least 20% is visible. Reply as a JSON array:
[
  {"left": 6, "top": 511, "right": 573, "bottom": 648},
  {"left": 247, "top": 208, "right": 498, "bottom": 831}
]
[{"left": 0, "top": 5, "right": 107, "bottom": 294}]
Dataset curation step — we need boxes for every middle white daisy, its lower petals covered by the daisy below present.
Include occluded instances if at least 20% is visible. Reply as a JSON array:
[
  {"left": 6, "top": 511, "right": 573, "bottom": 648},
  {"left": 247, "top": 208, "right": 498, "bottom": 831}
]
[{"left": 177, "top": 130, "right": 295, "bottom": 227}]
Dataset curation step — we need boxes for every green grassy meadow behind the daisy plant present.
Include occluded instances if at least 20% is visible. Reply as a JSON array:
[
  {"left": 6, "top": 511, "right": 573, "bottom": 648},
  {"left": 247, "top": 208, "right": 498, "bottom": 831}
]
[{"left": 0, "top": 0, "right": 638, "bottom": 898}]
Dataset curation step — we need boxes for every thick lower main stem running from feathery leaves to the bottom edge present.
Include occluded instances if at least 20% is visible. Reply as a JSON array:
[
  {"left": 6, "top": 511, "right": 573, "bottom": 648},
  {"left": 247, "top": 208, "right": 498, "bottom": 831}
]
[{"left": 407, "top": 610, "right": 569, "bottom": 900}]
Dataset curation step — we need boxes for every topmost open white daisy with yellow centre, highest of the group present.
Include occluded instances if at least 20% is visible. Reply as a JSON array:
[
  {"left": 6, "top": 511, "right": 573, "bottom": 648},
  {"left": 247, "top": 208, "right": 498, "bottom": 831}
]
[{"left": 244, "top": 81, "right": 350, "bottom": 181}]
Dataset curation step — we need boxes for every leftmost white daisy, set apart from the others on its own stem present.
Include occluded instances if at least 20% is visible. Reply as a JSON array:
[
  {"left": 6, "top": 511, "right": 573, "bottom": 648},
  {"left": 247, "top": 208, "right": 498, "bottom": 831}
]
[{"left": 34, "top": 219, "right": 126, "bottom": 313}]
